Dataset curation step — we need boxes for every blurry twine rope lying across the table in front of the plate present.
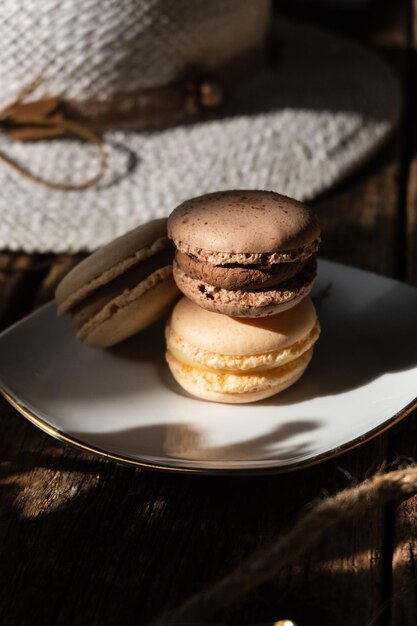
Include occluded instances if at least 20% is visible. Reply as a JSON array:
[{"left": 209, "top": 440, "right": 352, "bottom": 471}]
[{"left": 150, "top": 465, "right": 417, "bottom": 626}]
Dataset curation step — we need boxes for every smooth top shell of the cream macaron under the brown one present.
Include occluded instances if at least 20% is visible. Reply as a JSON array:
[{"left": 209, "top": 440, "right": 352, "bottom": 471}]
[{"left": 170, "top": 297, "right": 317, "bottom": 356}]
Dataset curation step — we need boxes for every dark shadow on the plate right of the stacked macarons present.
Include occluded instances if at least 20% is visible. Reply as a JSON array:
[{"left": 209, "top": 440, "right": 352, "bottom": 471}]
[{"left": 259, "top": 285, "right": 417, "bottom": 406}]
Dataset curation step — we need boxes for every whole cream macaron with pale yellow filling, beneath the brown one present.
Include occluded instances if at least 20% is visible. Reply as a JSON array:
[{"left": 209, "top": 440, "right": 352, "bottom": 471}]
[{"left": 166, "top": 297, "right": 320, "bottom": 404}]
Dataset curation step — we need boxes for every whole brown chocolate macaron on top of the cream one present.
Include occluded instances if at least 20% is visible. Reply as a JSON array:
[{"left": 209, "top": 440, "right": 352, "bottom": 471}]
[{"left": 168, "top": 190, "right": 320, "bottom": 317}]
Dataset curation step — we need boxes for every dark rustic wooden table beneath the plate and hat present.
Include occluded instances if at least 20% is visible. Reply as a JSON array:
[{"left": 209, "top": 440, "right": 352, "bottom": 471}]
[{"left": 0, "top": 0, "right": 417, "bottom": 626}]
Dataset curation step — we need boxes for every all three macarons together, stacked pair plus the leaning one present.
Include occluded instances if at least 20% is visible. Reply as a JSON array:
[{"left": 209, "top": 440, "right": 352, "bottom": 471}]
[{"left": 55, "top": 191, "right": 320, "bottom": 403}]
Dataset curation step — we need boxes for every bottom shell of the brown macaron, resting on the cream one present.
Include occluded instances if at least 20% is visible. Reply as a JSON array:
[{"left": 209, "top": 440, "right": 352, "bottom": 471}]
[{"left": 173, "top": 259, "right": 316, "bottom": 318}]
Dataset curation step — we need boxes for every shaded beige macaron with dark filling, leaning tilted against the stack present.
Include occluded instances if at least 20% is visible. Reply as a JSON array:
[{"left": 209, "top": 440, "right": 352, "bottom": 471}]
[{"left": 55, "top": 219, "right": 179, "bottom": 348}]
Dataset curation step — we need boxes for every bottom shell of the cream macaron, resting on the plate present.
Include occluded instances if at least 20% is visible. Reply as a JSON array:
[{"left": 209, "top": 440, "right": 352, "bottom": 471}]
[{"left": 167, "top": 348, "right": 313, "bottom": 404}]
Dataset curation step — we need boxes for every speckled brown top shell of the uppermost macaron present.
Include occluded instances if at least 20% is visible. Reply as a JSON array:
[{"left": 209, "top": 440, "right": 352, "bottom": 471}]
[{"left": 168, "top": 190, "right": 320, "bottom": 265}]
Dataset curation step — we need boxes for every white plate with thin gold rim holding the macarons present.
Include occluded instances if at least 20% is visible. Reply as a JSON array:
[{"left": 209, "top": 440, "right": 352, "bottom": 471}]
[{"left": 0, "top": 260, "right": 417, "bottom": 473}]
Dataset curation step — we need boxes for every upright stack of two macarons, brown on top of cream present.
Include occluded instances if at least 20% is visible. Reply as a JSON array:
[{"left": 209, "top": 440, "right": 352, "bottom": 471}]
[{"left": 166, "top": 191, "right": 320, "bottom": 403}]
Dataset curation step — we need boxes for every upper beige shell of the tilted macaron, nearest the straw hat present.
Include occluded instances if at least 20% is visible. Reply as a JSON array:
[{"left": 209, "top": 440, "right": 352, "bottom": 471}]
[{"left": 55, "top": 218, "right": 168, "bottom": 315}]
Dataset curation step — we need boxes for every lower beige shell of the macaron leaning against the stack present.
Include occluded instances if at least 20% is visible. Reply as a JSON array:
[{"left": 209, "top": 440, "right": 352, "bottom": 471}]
[{"left": 78, "top": 275, "right": 179, "bottom": 348}]
